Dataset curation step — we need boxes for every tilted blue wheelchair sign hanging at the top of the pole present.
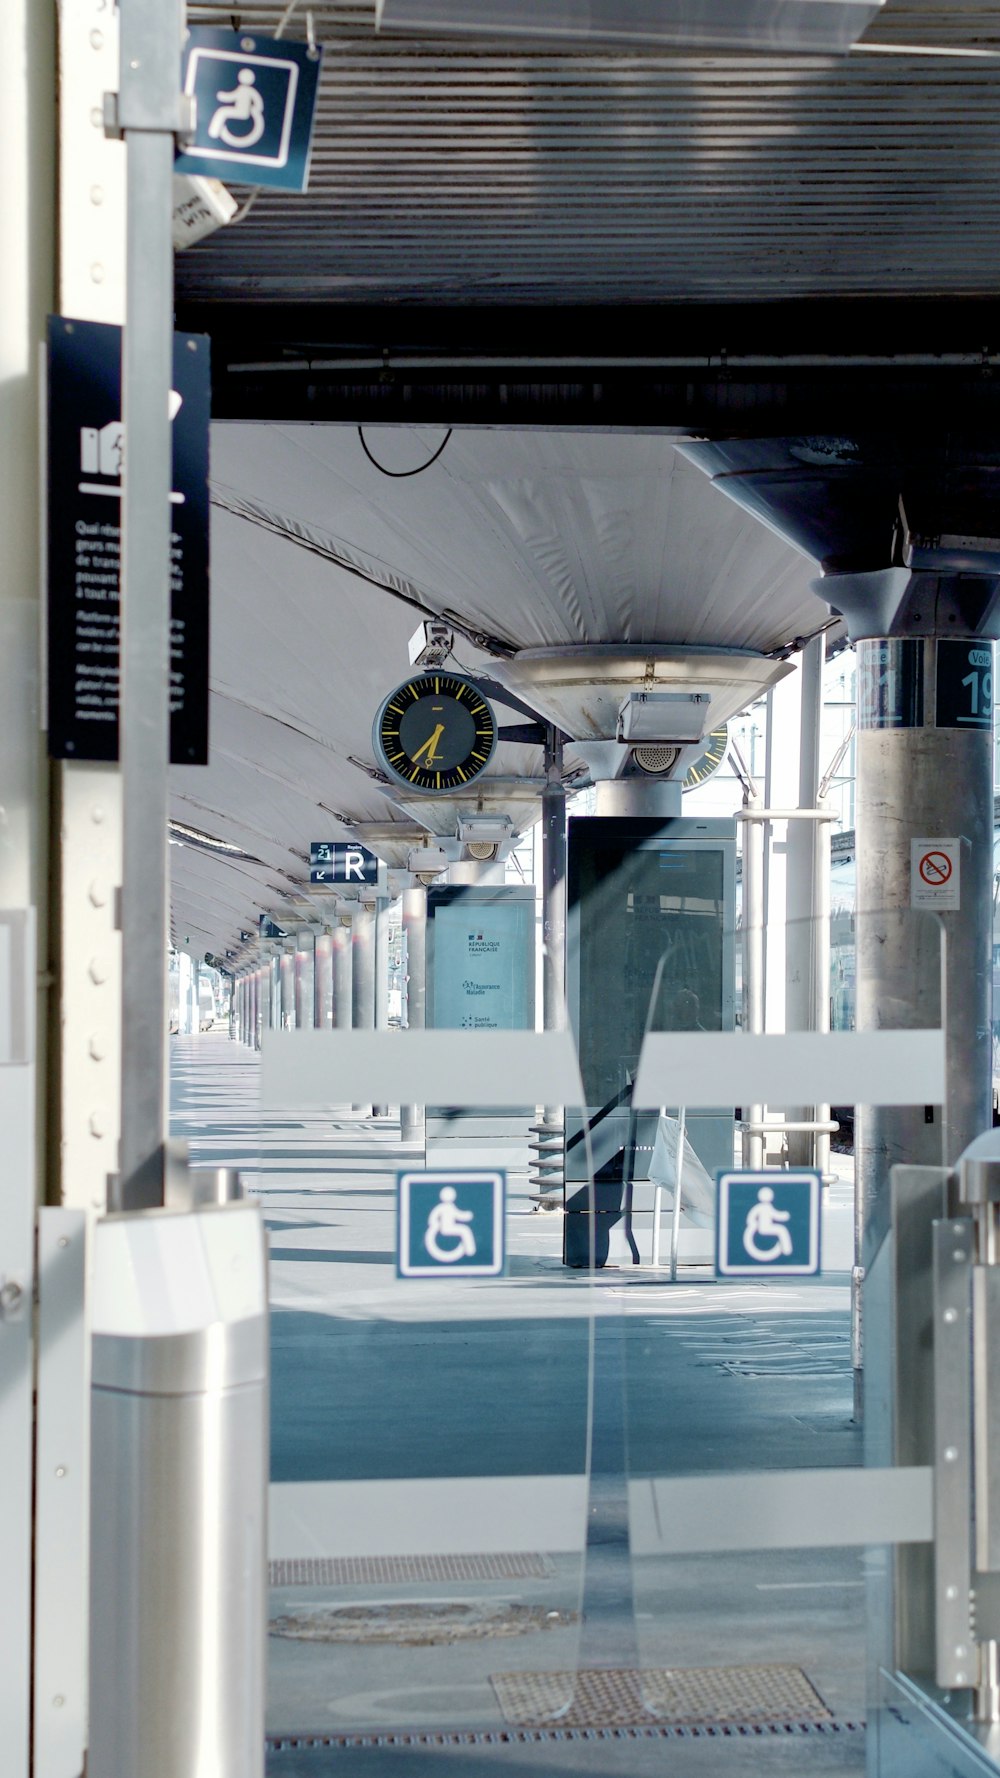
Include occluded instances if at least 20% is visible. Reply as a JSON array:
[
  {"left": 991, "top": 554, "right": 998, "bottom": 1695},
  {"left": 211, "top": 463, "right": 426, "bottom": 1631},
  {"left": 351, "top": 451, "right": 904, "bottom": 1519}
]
[{"left": 174, "top": 25, "right": 322, "bottom": 192}]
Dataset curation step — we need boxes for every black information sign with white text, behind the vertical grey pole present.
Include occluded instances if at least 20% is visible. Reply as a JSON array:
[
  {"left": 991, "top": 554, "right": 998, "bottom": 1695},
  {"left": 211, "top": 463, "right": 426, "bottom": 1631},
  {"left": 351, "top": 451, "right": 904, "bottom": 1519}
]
[{"left": 48, "top": 315, "right": 210, "bottom": 766}]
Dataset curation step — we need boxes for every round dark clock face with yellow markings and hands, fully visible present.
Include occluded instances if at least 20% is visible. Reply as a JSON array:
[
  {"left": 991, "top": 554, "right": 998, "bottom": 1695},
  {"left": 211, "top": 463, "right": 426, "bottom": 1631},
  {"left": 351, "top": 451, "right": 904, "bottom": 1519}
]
[{"left": 372, "top": 672, "right": 496, "bottom": 797}]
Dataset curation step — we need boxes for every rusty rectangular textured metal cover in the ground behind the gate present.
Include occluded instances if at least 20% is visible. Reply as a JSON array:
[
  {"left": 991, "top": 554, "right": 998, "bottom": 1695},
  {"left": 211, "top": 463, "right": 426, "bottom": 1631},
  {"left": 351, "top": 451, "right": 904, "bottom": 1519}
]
[{"left": 491, "top": 1666, "right": 831, "bottom": 1728}]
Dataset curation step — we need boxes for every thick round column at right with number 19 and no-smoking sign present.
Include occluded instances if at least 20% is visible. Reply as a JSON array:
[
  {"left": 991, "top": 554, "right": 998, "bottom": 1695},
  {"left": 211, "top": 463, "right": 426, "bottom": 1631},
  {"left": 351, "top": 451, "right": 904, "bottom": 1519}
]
[{"left": 822, "top": 576, "right": 998, "bottom": 1412}]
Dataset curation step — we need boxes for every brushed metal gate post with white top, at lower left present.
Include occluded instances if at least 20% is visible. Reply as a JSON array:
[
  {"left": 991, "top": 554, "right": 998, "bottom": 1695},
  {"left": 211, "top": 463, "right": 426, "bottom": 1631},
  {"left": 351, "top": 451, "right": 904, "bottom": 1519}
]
[{"left": 87, "top": 1202, "right": 269, "bottom": 1778}]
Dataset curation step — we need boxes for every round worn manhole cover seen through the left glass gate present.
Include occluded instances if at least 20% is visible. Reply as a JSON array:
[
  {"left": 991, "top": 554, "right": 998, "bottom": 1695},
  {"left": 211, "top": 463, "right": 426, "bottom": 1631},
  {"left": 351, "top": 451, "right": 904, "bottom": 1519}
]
[{"left": 269, "top": 1600, "right": 577, "bottom": 1648}]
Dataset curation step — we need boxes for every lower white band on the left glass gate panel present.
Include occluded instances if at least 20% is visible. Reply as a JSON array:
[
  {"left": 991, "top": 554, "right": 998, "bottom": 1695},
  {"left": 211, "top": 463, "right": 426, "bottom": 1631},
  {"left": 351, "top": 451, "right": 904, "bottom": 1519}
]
[{"left": 267, "top": 1476, "right": 587, "bottom": 1561}]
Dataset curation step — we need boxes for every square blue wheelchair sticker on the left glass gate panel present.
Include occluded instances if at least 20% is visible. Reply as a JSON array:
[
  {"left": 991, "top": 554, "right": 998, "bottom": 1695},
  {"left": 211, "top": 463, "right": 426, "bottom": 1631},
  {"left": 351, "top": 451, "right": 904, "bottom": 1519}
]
[{"left": 397, "top": 1172, "right": 505, "bottom": 1278}]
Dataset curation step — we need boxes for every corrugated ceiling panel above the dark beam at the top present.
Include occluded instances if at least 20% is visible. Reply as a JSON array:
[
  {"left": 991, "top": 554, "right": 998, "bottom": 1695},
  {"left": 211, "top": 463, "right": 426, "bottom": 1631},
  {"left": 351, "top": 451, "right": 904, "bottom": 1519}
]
[{"left": 178, "top": 0, "right": 1000, "bottom": 304}]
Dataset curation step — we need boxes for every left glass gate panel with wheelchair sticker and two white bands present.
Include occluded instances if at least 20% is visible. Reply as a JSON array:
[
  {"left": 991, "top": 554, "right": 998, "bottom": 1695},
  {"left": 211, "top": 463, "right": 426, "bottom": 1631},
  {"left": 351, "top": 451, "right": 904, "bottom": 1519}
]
[{"left": 256, "top": 1002, "right": 593, "bottom": 1750}]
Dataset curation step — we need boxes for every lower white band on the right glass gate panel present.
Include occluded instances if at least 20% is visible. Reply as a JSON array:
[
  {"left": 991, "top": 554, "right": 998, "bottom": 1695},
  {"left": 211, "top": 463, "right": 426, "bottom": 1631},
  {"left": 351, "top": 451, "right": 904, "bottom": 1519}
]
[{"left": 628, "top": 1465, "right": 934, "bottom": 1556}]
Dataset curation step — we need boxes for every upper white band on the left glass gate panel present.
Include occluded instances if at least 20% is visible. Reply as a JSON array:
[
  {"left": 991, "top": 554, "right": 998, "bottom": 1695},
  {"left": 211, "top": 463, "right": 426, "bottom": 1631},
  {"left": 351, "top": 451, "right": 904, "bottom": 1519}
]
[{"left": 260, "top": 1031, "right": 584, "bottom": 1111}]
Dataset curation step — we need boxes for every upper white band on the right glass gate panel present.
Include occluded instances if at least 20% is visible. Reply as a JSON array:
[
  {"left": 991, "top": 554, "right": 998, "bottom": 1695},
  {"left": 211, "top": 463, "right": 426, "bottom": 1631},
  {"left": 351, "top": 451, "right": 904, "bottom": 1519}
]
[{"left": 632, "top": 1031, "right": 945, "bottom": 1109}]
